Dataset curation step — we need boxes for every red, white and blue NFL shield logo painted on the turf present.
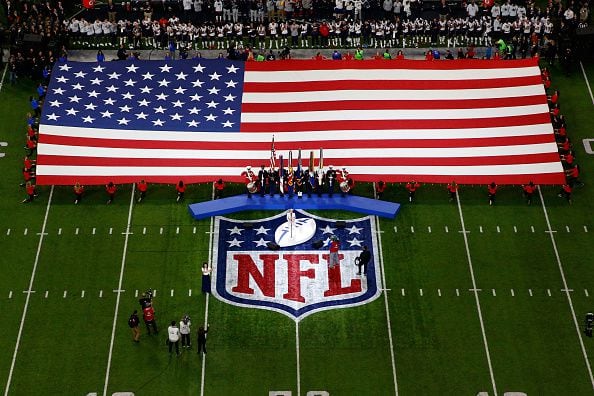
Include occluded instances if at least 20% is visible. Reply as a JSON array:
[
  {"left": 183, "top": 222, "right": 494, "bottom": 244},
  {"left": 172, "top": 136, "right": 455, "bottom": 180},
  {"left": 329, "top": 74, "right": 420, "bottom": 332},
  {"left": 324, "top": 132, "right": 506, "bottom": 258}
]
[{"left": 213, "top": 211, "right": 381, "bottom": 321}]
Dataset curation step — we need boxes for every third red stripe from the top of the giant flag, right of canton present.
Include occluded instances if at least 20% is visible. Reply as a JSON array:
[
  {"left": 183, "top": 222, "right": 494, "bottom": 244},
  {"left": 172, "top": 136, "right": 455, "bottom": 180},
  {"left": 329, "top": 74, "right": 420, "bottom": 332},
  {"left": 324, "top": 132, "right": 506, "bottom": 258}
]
[{"left": 241, "top": 95, "right": 544, "bottom": 113}]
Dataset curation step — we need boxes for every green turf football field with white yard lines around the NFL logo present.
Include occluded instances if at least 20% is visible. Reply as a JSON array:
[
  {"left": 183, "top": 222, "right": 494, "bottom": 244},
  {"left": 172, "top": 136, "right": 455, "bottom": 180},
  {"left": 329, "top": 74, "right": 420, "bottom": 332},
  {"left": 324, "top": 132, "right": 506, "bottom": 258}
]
[{"left": 0, "top": 58, "right": 594, "bottom": 395}]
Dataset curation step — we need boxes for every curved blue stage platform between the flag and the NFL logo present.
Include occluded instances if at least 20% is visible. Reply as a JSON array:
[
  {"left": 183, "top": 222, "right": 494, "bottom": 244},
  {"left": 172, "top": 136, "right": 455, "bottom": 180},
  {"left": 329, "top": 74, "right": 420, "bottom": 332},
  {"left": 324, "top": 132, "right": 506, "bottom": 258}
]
[{"left": 188, "top": 194, "right": 400, "bottom": 220}]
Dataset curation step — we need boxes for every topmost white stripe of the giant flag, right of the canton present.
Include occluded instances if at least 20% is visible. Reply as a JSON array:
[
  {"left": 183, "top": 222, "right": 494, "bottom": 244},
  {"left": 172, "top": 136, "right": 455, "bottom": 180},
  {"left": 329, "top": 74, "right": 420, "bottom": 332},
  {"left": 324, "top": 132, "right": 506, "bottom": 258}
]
[{"left": 244, "top": 66, "right": 540, "bottom": 83}]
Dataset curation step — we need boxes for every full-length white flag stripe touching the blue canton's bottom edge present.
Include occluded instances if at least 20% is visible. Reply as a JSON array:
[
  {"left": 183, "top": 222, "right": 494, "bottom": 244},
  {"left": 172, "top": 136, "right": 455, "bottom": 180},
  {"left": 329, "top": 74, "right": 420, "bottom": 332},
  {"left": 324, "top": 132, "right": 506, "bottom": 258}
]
[{"left": 39, "top": 123, "right": 553, "bottom": 142}]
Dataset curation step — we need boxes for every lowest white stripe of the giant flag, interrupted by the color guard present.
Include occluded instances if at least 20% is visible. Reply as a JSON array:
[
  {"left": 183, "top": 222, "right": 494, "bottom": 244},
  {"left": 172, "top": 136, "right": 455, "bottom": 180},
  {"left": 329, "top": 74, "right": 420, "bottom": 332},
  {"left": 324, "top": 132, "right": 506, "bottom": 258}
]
[{"left": 37, "top": 162, "right": 563, "bottom": 177}]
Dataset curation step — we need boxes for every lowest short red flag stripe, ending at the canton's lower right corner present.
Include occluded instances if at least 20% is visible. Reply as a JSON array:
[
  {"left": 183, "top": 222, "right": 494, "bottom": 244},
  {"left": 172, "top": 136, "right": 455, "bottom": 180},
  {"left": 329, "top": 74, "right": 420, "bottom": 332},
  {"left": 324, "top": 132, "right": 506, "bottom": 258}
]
[{"left": 241, "top": 113, "right": 550, "bottom": 133}]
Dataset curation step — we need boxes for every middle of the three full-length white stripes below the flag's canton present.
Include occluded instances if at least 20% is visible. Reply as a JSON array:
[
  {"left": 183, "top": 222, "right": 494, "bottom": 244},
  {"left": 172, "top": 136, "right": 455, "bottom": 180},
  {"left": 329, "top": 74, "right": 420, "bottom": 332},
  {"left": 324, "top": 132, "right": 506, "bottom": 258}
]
[{"left": 37, "top": 142, "right": 557, "bottom": 160}]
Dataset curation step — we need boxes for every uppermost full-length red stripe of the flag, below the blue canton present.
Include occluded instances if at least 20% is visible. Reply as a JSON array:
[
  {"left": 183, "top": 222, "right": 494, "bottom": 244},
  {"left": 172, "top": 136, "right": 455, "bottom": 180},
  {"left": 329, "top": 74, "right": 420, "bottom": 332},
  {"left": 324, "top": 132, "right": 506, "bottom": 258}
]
[{"left": 41, "top": 133, "right": 554, "bottom": 151}]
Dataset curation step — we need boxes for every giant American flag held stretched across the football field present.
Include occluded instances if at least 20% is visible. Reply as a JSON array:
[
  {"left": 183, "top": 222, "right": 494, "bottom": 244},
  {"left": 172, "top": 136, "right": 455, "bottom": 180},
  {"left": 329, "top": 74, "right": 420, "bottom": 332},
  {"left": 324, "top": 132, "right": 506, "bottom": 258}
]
[{"left": 37, "top": 59, "right": 564, "bottom": 184}]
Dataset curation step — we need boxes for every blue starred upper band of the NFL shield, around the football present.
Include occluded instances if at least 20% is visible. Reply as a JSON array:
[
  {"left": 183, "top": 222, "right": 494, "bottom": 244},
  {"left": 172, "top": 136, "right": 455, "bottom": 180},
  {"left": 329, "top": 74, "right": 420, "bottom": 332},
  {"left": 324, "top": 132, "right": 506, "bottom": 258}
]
[{"left": 219, "top": 213, "right": 373, "bottom": 251}]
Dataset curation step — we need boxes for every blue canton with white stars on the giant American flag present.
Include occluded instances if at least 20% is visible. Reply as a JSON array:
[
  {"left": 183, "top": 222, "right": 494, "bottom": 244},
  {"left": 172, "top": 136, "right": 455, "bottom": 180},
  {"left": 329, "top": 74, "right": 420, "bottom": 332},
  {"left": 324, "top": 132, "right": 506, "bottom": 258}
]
[{"left": 42, "top": 59, "right": 244, "bottom": 132}]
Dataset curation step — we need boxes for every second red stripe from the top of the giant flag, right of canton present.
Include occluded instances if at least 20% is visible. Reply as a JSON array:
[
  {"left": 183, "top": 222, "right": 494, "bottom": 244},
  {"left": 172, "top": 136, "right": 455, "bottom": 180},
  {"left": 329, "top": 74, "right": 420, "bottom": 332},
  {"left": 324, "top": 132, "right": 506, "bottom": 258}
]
[{"left": 243, "top": 76, "right": 542, "bottom": 92}]
